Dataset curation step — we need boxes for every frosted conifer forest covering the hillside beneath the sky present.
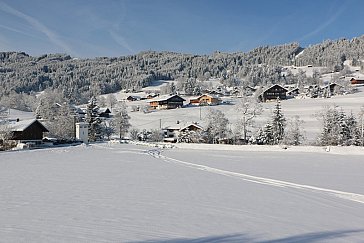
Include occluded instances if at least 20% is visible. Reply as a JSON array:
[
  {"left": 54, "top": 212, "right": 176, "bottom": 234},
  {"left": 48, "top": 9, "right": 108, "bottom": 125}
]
[{"left": 0, "top": 36, "right": 364, "bottom": 107}]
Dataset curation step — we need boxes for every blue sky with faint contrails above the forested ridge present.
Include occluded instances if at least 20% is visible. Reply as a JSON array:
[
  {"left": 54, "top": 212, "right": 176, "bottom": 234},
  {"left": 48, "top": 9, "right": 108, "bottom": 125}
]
[{"left": 0, "top": 0, "right": 364, "bottom": 57}]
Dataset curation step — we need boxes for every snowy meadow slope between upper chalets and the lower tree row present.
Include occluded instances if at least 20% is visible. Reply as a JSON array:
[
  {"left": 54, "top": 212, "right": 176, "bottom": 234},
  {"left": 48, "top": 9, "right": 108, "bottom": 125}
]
[{"left": 126, "top": 87, "right": 364, "bottom": 144}]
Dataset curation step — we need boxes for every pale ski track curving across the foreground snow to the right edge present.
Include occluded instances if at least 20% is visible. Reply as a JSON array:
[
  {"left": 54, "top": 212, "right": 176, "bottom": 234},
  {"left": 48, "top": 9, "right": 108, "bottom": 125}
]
[{"left": 147, "top": 149, "right": 364, "bottom": 204}]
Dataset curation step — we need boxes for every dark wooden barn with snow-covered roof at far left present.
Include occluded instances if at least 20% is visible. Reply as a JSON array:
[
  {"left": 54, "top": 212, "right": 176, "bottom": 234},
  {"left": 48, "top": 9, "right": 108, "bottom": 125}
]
[{"left": 10, "top": 119, "right": 49, "bottom": 144}]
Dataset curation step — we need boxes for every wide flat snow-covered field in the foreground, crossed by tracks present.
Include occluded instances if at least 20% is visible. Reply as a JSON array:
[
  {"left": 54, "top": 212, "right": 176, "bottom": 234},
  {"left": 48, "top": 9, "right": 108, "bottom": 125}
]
[{"left": 0, "top": 143, "right": 364, "bottom": 243}]
